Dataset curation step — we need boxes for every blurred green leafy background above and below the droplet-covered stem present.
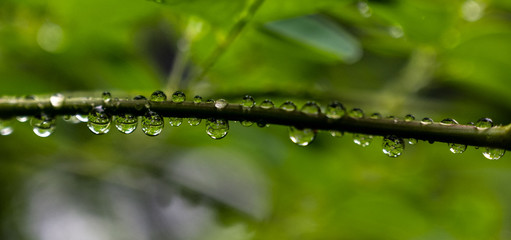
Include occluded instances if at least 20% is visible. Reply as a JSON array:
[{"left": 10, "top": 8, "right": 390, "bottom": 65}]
[{"left": 0, "top": 0, "right": 511, "bottom": 240}]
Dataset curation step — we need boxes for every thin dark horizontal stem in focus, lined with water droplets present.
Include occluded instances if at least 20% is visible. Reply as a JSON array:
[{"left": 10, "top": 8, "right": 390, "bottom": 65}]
[{"left": 0, "top": 98, "right": 511, "bottom": 150}]
